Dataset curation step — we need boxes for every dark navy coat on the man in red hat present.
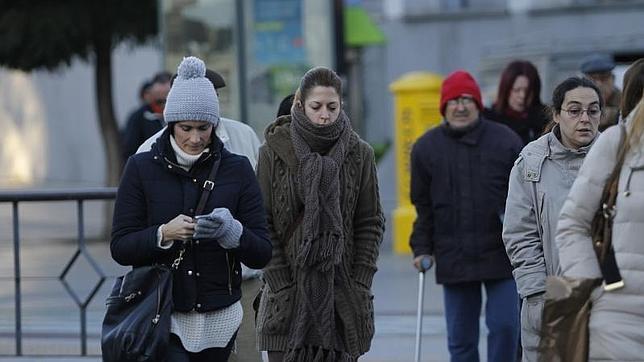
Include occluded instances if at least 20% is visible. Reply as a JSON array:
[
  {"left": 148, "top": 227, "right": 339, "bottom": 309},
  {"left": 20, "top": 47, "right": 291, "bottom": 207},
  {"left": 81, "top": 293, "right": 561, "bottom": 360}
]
[{"left": 410, "top": 118, "right": 522, "bottom": 283}]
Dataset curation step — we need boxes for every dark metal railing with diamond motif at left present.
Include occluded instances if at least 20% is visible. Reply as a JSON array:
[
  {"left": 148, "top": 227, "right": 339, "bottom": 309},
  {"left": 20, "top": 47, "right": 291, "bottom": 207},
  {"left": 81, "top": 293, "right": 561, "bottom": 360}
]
[{"left": 0, "top": 187, "right": 116, "bottom": 356}]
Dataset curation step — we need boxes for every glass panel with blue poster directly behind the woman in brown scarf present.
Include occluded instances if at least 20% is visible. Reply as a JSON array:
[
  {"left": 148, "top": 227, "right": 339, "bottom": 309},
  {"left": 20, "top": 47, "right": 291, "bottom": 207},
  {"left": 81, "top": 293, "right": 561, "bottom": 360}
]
[{"left": 245, "top": 0, "right": 335, "bottom": 133}]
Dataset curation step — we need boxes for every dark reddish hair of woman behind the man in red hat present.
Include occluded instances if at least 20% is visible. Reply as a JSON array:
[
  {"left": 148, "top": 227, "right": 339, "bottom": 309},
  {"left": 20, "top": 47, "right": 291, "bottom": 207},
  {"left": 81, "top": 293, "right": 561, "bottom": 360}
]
[{"left": 494, "top": 60, "right": 543, "bottom": 114}]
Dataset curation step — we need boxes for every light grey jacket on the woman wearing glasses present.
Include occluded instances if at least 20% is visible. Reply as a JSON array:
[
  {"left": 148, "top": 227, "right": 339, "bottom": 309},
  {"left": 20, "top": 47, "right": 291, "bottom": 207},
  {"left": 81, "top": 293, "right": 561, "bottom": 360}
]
[{"left": 503, "top": 126, "right": 592, "bottom": 298}]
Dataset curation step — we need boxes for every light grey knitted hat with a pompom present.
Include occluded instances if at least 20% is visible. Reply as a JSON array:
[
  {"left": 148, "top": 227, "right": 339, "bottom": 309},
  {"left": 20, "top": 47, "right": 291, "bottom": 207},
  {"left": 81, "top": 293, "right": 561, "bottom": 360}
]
[{"left": 163, "top": 57, "right": 219, "bottom": 126}]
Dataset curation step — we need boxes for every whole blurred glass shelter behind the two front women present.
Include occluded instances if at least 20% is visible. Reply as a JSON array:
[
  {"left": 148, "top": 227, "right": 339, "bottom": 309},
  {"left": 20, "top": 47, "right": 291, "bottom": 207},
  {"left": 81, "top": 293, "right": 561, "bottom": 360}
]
[{"left": 161, "top": 0, "right": 342, "bottom": 137}]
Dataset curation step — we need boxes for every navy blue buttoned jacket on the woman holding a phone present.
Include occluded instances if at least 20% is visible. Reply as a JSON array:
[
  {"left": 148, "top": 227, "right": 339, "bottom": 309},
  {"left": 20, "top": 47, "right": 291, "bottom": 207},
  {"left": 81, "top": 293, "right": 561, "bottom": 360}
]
[{"left": 110, "top": 131, "right": 272, "bottom": 312}]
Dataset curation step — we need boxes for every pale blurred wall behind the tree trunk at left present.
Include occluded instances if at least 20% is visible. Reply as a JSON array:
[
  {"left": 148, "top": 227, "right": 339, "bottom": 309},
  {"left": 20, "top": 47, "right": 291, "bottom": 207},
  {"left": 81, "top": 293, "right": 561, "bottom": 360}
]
[{"left": 0, "top": 45, "right": 161, "bottom": 187}]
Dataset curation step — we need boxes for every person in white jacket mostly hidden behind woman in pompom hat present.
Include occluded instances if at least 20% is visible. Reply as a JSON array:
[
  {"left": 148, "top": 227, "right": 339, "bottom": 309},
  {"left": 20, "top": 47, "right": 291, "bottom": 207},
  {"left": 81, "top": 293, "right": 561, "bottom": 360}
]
[{"left": 137, "top": 69, "right": 262, "bottom": 362}]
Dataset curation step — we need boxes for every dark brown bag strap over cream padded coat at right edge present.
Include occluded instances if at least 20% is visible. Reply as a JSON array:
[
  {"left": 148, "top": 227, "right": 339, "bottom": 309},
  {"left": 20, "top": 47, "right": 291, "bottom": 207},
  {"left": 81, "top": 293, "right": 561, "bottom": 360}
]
[{"left": 591, "top": 123, "right": 627, "bottom": 291}]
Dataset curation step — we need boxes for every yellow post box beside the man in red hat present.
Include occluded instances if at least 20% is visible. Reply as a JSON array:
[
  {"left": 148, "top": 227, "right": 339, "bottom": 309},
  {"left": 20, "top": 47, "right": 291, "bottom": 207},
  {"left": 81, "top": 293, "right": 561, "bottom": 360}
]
[{"left": 389, "top": 72, "right": 443, "bottom": 254}]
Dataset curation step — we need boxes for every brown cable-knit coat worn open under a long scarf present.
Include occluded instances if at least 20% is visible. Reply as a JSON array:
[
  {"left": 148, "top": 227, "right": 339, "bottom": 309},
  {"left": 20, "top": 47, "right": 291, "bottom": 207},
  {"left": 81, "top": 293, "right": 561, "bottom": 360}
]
[{"left": 257, "top": 116, "right": 384, "bottom": 358}]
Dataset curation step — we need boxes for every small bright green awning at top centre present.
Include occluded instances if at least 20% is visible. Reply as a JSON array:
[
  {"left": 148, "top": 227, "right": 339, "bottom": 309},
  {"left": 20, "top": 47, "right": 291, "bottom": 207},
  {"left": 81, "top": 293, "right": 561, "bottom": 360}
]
[{"left": 344, "top": 6, "right": 386, "bottom": 47}]
